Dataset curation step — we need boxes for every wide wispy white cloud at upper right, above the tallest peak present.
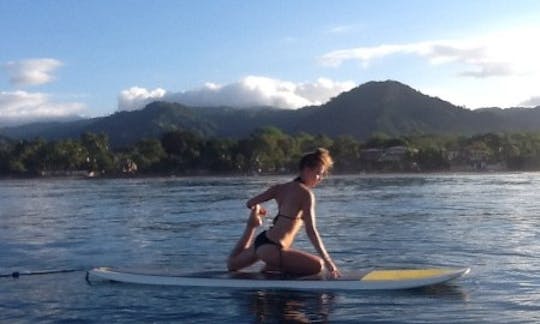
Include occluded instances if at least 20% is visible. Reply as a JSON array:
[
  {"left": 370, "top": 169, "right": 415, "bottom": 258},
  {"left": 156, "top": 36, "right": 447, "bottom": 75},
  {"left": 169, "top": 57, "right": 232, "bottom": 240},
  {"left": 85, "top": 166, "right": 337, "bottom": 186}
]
[{"left": 320, "top": 27, "right": 540, "bottom": 78}]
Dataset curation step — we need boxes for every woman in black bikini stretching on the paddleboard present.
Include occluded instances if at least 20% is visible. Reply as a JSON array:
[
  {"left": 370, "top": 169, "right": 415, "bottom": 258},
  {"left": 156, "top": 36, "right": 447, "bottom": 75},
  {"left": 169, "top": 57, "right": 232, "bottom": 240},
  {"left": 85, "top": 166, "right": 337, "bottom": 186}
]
[{"left": 227, "top": 148, "right": 340, "bottom": 278}]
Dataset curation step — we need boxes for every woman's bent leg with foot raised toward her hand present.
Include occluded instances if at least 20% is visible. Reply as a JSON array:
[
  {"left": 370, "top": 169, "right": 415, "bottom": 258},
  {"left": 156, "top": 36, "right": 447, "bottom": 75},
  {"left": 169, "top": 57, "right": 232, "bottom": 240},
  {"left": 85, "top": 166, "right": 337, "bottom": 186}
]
[{"left": 227, "top": 207, "right": 262, "bottom": 271}]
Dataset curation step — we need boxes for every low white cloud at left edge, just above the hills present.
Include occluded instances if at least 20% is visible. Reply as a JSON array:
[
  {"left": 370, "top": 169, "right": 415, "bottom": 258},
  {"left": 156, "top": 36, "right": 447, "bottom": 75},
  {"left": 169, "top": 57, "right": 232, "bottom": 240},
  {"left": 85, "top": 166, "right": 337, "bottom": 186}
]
[{"left": 0, "top": 91, "right": 85, "bottom": 126}]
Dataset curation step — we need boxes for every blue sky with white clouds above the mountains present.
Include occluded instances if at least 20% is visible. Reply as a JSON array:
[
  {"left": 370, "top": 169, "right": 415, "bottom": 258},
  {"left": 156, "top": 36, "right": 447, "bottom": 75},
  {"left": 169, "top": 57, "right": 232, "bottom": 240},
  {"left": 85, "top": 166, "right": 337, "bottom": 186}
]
[{"left": 0, "top": 0, "right": 540, "bottom": 126}]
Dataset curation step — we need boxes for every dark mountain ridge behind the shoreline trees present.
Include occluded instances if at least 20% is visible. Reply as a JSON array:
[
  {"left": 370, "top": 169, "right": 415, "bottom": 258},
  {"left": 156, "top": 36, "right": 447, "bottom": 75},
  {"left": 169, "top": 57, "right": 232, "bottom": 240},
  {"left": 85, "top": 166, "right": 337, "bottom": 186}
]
[{"left": 0, "top": 80, "right": 540, "bottom": 146}]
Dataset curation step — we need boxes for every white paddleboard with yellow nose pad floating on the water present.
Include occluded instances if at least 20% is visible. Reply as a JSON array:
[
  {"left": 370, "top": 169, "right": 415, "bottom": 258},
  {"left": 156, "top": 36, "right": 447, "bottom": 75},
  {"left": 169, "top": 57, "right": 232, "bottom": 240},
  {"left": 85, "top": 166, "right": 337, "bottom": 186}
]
[{"left": 87, "top": 267, "right": 470, "bottom": 290}]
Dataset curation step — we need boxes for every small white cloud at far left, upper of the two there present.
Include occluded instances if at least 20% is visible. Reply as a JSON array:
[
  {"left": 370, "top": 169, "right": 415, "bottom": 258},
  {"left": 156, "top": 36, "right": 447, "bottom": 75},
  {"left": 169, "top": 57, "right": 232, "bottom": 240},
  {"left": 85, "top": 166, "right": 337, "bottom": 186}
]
[{"left": 4, "top": 58, "right": 62, "bottom": 86}]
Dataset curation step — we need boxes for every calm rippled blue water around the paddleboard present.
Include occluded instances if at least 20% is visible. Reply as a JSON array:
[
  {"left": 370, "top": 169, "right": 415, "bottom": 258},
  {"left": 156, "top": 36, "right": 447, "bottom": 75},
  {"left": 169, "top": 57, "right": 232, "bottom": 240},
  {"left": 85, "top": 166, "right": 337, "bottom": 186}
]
[{"left": 0, "top": 173, "right": 540, "bottom": 323}]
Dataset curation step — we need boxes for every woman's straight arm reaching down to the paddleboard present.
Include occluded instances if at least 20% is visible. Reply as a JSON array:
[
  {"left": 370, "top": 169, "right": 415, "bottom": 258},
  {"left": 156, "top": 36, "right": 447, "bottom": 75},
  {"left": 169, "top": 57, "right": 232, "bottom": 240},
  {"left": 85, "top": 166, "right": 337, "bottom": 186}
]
[{"left": 302, "top": 192, "right": 341, "bottom": 278}]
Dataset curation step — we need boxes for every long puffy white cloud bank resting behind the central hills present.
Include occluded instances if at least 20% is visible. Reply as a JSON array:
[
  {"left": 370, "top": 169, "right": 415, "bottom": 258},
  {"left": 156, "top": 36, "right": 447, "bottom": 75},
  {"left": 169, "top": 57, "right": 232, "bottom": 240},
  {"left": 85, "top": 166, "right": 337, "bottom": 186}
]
[{"left": 118, "top": 76, "right": 355, "bottom": 110}]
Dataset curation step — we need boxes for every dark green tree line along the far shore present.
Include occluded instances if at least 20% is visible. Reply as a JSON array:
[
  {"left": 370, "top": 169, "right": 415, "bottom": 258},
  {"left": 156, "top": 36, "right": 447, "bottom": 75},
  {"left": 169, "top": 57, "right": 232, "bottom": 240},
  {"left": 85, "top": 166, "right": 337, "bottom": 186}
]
[{"left": 0, "top": 127, "right": 540, "bottom": 176}]
